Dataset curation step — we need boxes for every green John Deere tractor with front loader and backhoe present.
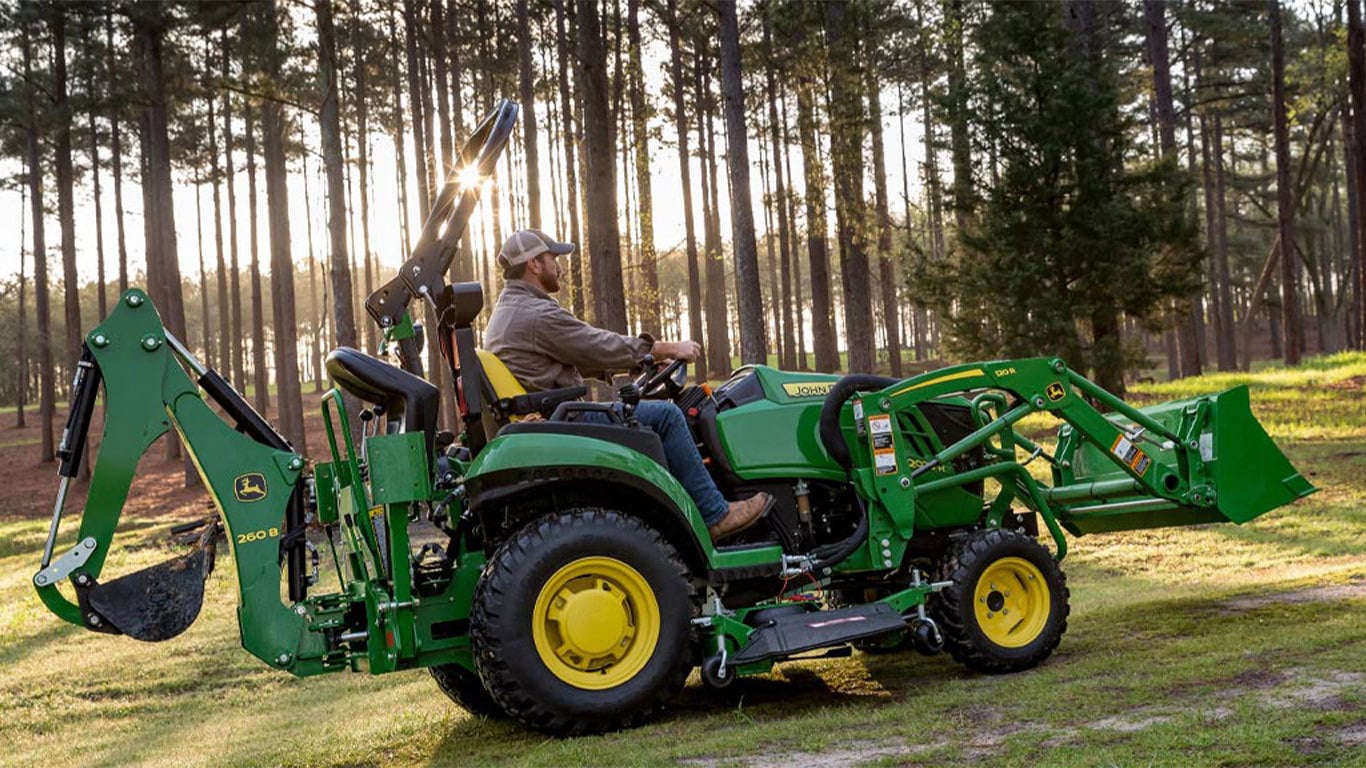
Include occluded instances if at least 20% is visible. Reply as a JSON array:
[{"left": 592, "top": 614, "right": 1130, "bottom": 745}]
[{"left": 33, "top": 101, "right": 1314, "bottom": 735}]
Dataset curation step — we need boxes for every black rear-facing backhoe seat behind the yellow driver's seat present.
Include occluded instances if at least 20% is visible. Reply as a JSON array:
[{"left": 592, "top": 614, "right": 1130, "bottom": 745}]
[{"left": 326, "top": 347, "right": 441, "bottom": 458}]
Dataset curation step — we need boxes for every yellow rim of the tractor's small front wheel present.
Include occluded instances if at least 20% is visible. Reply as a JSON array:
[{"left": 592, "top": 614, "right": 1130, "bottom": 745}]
[{"left": 973, "top": 558, "right": 1052, "bottom": 648}]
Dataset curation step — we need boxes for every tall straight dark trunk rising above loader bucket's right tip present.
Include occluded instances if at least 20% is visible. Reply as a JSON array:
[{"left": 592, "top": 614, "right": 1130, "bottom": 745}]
[{"left": 1268, "top": 0, "right": 1302, "bottom": 365}]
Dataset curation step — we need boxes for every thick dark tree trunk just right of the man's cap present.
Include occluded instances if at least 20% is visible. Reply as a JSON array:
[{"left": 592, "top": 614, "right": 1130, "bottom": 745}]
[{"left": 575, "top": 3, "right": 626, "bottom": 333}]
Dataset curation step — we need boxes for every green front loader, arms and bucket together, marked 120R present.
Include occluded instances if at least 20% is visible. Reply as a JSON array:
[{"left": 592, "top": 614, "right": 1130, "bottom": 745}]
[{"left": 844, "top": 358, "right": 1314, "bottom": 559}]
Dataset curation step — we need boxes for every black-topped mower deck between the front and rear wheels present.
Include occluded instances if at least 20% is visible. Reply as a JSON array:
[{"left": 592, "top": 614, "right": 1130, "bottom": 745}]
[{"left": 731, "top": 603, "right": 906, "bottom": 664}]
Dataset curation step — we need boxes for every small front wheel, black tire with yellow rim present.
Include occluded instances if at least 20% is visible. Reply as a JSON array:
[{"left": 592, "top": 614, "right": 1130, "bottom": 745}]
[{"left": 932, "top": 529, "right": 1070, "bottom": 674}]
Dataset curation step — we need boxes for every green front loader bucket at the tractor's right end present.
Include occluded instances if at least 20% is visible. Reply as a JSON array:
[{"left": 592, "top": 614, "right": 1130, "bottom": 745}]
[{"left": 1050, "top": 385, "right": 1317, "bottom": 534}]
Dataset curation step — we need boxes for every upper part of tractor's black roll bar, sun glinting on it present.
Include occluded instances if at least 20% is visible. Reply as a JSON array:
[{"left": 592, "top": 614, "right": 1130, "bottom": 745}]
[{"left": 365, "top": 98, "right": 520, "bottom": 328}]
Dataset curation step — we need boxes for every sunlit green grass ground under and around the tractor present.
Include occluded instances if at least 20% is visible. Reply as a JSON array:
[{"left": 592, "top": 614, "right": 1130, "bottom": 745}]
[{"left": 0, "top": 354, "right": 1366, "bottom": 767}]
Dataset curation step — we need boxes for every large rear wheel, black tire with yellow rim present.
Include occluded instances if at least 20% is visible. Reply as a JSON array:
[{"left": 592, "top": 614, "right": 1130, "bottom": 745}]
[{"left": 471, "top": 511, "right": 693, "bottom": 735}]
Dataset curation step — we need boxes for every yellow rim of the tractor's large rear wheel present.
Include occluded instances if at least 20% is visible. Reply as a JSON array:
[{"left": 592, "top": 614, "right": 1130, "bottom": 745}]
[{"left": 531, "top": 558, "right": 660, "bottom": 690}]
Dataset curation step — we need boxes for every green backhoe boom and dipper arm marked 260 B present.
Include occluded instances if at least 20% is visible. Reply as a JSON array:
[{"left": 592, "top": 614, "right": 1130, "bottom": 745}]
[{"left": 34, "top": 290, "right": 325, "bottom": 667}]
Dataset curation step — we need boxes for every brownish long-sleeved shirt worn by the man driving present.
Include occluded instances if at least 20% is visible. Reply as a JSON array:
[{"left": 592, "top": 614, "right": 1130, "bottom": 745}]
[{"left": 484, "top": 280, "right": 653, "bottom": 392}]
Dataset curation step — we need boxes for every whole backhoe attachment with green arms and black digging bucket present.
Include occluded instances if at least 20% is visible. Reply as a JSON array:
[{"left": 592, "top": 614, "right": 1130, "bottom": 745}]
[{"left": 33, "top": 290, "right": 307, "bottom": 666}]
